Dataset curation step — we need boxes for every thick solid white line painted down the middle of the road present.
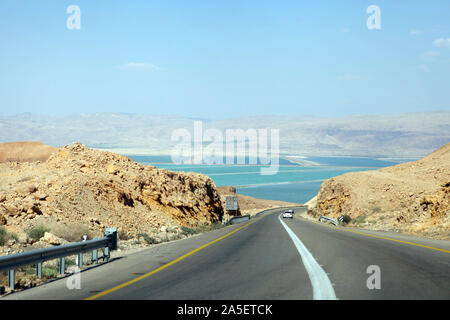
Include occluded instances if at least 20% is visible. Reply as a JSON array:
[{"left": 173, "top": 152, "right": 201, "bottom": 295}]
[{"left": 278, "top": 214, "right": 337, "bottom": 300}]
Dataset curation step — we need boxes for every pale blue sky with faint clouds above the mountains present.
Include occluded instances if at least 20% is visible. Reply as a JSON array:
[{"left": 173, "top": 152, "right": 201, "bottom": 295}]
[{"left": 0, "top": 0, "right": 450, "bottom": 119}]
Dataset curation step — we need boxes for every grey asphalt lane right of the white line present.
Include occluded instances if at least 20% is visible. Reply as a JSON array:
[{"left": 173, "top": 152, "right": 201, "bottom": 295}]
[{"left": 288, "top": 214, "right": 450, "bottom": 299}]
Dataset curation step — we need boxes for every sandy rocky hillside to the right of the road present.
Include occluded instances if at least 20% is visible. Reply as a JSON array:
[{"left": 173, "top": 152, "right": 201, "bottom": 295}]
[{"left": 309, "top": 143, "right": 450, "bottom": 239}]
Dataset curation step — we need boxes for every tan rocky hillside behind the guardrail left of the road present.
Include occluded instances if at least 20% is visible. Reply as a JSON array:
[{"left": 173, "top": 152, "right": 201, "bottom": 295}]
[{"left": 0, "top": 143, "right": 223, "bottom": 240}]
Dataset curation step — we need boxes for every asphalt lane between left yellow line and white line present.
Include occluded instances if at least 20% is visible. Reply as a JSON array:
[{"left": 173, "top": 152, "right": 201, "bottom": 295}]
[{"left": 96, "top": 209, "right": 312, "bottom": 300}]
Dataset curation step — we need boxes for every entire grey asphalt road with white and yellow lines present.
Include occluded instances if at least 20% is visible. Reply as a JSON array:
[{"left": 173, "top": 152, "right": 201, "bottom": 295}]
[{"left": 3, "top": 210, "right": 450, "bottom": 300}]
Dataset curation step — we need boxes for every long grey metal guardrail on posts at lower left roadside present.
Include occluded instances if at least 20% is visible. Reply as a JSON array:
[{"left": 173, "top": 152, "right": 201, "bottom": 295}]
[{"left": 0, "top": 228, "right": 117, "bottom": 289}]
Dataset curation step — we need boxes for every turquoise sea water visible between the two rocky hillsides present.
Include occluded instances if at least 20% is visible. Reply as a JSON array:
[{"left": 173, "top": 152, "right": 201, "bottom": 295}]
[{"left": 129, "top": 155, "right": 413, "bottom": 203}]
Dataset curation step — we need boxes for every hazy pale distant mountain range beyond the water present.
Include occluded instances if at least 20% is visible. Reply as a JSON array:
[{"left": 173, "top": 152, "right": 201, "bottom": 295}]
[{"left": 0, "top": 111, "right": 450, "bottom": 157}]
